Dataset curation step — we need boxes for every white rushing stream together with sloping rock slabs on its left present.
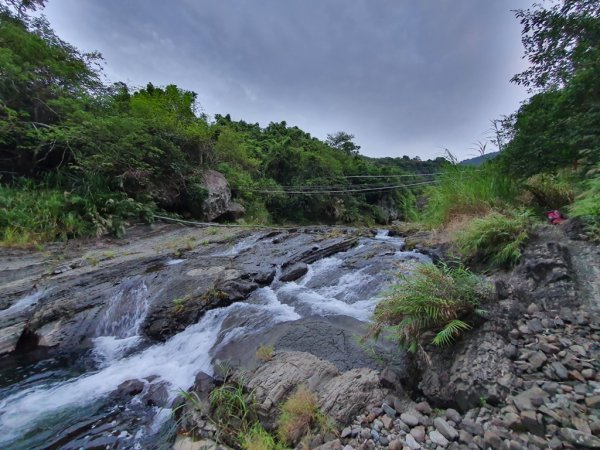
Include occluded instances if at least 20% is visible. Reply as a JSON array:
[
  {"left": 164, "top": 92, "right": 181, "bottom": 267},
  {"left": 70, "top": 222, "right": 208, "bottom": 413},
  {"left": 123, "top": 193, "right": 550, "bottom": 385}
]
[{"left": 0, "top": 225, "right": 429, "bottom": 448}]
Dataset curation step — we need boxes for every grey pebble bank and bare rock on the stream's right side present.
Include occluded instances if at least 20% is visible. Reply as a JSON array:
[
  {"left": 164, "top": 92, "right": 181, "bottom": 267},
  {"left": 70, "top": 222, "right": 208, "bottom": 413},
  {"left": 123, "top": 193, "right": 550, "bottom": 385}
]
[{"left": 176, "top": 223, "right": 600, "bottom": 450}]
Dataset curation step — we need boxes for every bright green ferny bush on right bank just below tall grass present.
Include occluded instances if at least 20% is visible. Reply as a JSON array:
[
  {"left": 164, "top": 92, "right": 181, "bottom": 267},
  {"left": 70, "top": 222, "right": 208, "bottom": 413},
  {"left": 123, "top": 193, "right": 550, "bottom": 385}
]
[{"left": 455, "top": 210, "right": 533, "bottom": 268}]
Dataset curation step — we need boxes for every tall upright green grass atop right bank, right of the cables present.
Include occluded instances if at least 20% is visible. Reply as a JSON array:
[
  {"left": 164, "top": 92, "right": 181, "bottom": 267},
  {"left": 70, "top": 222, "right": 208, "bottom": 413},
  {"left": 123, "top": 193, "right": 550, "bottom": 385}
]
[{"left": 422, "top": 163, "right": 519, "bottom": 226}]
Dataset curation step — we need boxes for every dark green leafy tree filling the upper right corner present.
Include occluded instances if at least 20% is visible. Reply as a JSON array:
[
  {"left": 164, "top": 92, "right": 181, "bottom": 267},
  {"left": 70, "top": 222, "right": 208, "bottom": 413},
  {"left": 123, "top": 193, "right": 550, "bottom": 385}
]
[{"left": 500, "top": 0, "right": 600, "bottom": 178}]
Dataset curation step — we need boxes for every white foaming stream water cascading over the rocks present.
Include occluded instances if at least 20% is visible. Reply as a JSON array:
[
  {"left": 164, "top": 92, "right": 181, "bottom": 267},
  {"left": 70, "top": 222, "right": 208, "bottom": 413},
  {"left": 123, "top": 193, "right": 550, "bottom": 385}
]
[{"left": 0, "top": 231, "right": 428, "bottom": 449}]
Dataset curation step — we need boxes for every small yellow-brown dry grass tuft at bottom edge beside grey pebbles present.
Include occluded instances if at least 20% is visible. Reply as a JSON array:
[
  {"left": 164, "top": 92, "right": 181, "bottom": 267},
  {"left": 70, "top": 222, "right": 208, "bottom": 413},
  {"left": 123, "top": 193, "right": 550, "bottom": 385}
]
[{"left": 277, "top": 386, "right": 328, "bottom": 444}]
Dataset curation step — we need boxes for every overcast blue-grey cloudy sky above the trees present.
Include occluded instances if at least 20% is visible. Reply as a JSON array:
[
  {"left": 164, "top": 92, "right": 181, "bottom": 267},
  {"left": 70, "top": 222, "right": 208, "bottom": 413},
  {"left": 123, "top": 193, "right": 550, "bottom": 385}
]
[{"left": 45, "top": 0, "right": 531, "bottom": 162}]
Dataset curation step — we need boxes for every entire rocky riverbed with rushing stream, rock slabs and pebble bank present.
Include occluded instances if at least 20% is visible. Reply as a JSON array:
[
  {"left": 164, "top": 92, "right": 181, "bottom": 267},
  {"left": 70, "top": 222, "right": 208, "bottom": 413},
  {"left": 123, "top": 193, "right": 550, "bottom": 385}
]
[{"left": 0, "top": 225, "right": 600, "bottom": 450}]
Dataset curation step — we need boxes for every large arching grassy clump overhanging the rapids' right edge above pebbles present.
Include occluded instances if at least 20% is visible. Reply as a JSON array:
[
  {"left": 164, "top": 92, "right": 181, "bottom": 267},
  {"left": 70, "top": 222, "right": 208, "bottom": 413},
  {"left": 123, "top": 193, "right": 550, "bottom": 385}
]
[{"left": 371, "top": 264, "right": 486, "bottom": 352}]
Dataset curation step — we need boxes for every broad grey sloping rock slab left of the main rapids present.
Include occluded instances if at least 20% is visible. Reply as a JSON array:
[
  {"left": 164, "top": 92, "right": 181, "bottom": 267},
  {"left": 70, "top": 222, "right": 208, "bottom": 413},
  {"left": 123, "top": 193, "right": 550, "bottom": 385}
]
[{"left": 0, "top": 226, "right": 357, "bottom": 355}]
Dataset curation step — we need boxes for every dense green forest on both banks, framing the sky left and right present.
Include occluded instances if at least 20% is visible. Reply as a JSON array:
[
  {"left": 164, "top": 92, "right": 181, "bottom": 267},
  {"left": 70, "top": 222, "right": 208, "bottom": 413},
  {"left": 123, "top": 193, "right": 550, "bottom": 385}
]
[{"left": 0, "top": 0, "right": 600, "bottom": 245}]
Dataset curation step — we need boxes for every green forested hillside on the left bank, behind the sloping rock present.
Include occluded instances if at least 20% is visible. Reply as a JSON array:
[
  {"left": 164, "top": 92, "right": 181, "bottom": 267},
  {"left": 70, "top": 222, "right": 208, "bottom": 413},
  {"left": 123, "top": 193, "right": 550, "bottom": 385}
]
[{"left": 0, "top": 1, "right": 444, "bottom": 244}]
